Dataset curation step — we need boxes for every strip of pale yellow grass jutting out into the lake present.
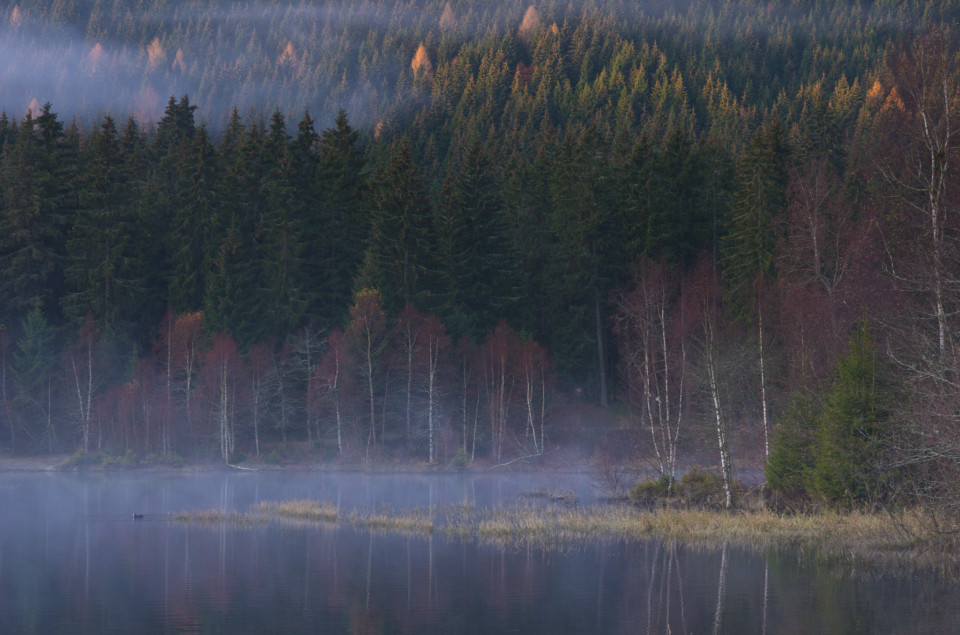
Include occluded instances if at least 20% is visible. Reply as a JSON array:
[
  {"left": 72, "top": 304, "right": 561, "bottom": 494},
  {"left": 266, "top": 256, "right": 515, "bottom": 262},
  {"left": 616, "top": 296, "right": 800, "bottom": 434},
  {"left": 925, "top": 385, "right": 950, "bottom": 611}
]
[{"left": 171, "top": 500, "right": 956, "bottom": 567}]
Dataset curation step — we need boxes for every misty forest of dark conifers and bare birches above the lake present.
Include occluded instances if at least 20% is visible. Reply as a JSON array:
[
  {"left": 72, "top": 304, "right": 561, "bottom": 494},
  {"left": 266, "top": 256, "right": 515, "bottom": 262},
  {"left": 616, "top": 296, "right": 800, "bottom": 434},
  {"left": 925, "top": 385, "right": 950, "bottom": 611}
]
[{"left": 0, "top": 0, "right": 960, "bottom": 516}]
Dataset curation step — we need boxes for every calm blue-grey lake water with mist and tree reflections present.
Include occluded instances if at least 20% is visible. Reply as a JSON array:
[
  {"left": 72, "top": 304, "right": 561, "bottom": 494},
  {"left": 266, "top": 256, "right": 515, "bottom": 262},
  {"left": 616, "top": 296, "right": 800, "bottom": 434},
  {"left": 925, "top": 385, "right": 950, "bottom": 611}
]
[{"left": 0, "top": 472, "right": 960, "bottom": 633}]
